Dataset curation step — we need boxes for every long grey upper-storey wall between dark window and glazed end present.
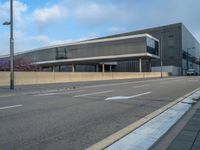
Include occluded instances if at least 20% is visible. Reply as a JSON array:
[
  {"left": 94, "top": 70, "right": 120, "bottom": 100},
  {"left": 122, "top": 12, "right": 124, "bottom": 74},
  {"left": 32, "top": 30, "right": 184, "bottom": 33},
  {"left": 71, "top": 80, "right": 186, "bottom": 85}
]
[{"left": 67, "top": 37, "right": 146, "bottom": 58}]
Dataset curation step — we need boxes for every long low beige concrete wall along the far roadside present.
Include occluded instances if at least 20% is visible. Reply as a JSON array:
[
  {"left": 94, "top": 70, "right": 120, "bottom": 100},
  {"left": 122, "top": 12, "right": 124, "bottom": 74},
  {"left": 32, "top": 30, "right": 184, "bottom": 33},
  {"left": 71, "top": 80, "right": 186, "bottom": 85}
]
[{"left": 0, "top": 72, "right": 168, "bottom": 86}]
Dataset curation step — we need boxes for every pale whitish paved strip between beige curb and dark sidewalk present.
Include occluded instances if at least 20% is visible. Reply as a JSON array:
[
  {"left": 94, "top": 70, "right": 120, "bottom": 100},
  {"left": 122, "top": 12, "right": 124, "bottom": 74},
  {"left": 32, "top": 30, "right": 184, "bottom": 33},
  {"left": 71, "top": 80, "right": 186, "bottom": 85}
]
[{"left": 105, "top": 91, "right": 199, "bottom": 150}]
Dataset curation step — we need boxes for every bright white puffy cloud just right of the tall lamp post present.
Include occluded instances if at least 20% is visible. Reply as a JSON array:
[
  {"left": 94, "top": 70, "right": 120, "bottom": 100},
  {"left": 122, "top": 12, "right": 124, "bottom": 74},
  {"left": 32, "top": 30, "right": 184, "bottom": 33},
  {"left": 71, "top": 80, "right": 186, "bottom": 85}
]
[{"left": 32, "top": 5, "right": 67, "bottom": 26}]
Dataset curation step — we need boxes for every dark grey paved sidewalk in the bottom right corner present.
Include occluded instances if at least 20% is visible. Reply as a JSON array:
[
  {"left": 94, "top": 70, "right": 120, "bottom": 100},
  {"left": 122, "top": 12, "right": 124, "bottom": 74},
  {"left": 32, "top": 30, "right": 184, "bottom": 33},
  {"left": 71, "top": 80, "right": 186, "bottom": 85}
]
[{"left": 167, "top": 108, "right": 200, "bottom": 150}]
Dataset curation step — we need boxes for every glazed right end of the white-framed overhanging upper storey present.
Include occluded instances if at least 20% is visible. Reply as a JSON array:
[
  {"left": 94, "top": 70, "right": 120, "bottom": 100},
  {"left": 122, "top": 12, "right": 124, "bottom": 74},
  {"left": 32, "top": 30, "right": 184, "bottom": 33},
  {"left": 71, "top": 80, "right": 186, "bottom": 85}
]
[{"left": 147, "top": 37, "right": 159, "bottom": 56}]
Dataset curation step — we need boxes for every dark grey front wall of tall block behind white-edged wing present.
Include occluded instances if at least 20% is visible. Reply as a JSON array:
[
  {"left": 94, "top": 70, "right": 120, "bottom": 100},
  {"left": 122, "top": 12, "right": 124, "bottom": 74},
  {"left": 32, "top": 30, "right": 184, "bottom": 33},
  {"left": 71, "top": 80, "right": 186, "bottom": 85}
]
[{"left": 95, "top": 23, "right": 182, "bottom": 67}]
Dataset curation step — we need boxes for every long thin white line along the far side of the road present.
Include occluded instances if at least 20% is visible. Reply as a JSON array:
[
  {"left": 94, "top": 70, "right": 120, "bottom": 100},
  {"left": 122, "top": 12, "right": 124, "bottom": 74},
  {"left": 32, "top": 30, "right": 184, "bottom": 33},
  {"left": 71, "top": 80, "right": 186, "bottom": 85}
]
[{"left": 83, "top": 77, "right": 180, "bottom": 89}]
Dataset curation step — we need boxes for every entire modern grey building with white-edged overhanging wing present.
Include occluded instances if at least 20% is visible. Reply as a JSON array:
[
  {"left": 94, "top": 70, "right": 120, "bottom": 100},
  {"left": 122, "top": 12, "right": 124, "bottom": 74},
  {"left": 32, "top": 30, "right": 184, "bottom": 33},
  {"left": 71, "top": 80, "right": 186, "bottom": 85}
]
[{"left": 0, "top": 23, "right": 200, "bottom": 75}]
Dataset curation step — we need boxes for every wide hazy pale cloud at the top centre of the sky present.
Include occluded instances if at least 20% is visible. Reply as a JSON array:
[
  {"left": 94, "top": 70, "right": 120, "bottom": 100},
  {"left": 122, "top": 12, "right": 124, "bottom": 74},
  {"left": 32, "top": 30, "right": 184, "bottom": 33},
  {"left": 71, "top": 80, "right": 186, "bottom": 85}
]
[{"left": 74, "top": 2, "right": 135, "bottom": 26}]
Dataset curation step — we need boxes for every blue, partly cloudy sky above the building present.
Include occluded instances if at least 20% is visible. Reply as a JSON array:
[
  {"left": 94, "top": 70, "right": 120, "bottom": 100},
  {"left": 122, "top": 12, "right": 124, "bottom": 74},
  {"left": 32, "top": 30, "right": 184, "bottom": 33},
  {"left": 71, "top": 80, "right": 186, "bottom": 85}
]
[{"left": 0, "top": 0, "right": 200, "bottom": 55}]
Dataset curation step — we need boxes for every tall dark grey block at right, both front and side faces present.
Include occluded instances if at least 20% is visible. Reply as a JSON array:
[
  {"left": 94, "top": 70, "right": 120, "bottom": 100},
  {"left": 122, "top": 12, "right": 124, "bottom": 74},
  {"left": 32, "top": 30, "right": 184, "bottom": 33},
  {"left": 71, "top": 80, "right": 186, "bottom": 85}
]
[{"left": 98, "top": 23, "right": 200, "bottom": 75}]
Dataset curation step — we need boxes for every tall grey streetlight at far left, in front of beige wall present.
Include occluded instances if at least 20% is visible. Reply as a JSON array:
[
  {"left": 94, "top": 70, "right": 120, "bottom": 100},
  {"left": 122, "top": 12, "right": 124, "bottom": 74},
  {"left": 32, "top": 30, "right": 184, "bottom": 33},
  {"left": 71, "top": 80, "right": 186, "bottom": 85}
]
[{"left": 3, "top": 0, "right": 14, "bottom": 89}]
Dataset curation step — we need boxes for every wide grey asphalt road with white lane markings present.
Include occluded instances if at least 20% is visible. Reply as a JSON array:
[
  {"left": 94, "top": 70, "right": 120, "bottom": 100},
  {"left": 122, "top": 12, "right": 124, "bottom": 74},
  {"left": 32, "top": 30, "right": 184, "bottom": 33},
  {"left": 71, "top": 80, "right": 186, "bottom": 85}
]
[{"left": 0, "top": 77, "right": 200, "bottom": 150}]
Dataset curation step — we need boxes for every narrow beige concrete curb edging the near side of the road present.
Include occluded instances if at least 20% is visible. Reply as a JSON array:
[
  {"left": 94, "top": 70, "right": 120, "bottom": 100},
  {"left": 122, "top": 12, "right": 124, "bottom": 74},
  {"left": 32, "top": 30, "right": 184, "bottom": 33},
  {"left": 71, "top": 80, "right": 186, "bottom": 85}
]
[{"left": 86, "top": 88, "right": 200, "bottom": 150}]
